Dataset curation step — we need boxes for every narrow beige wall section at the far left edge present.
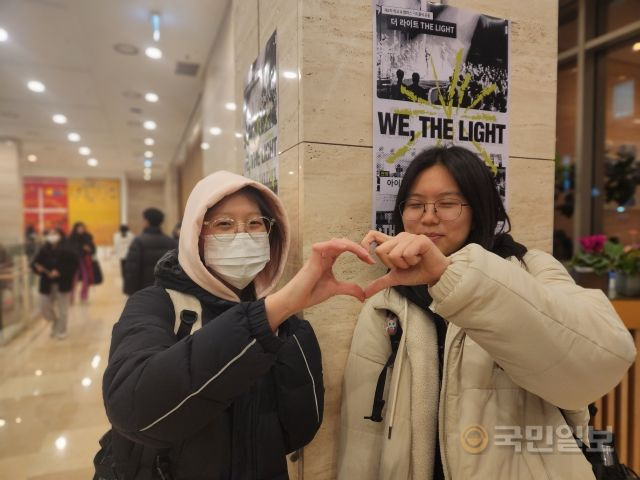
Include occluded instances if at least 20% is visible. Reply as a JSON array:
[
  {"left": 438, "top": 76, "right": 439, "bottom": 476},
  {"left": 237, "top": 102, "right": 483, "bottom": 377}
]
[{"left": 0, "top": 140, "right": 24, "bottom": 245}]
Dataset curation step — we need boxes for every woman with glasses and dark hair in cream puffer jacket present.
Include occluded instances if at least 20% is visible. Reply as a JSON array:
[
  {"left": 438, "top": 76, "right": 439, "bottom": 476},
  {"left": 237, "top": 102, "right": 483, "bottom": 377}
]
[{"left": 338, "top": 147, "right": 636, "bottom": 480}]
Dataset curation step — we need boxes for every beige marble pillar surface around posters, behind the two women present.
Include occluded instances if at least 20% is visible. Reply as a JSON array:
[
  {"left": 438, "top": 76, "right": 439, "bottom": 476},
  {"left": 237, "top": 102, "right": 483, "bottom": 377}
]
[{"left": 232, "top": 0, "right": 557, "bottom": 480}]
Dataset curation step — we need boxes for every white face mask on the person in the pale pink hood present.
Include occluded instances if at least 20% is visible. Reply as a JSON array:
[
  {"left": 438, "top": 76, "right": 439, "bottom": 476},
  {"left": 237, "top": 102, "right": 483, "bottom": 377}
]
[{"left": 204, "top": 232, "right": 271, "bottom": 290}]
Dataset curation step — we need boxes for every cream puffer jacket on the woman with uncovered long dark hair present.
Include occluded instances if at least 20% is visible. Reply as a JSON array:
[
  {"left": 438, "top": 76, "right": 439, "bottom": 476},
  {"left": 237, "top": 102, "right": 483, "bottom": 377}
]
[{"left": 338, "top": 244, "right": 636, "bottom": 480}]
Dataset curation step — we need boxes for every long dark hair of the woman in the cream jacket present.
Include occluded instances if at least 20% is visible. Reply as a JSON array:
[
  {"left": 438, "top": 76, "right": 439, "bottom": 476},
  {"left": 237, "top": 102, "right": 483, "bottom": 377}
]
[{"left": 392, "top": 146, "right": 527, "bottom": 261}]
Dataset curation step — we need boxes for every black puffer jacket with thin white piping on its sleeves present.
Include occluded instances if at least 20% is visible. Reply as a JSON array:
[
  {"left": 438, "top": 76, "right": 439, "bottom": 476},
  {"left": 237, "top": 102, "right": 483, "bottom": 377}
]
[{"left": 103, "top": 252, "right": 324, "bottom": 480}]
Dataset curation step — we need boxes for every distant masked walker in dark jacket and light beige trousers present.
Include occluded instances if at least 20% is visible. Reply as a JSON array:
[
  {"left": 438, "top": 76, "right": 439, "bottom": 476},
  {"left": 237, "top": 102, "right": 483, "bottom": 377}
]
[{"left": 31, "top": 228, "right": 79, "bottom": 340}]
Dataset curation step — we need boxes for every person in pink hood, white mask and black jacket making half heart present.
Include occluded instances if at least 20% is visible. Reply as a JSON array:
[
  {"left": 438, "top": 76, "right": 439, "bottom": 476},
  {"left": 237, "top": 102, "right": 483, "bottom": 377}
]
[{"left": 103, "top": 171, "right": 373, "bottom": 480}]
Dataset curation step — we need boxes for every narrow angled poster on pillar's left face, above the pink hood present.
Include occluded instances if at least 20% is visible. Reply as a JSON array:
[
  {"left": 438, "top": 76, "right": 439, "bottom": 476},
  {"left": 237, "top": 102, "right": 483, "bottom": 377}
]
[{"left": 242, "top": 31, "right": 278, "bottom": 193}]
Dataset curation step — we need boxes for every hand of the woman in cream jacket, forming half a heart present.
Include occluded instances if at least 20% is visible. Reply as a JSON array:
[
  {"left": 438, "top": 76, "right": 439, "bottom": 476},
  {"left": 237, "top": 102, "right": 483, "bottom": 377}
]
[{"left": 361, "top": 230, "right": 451, "bottom": 298}]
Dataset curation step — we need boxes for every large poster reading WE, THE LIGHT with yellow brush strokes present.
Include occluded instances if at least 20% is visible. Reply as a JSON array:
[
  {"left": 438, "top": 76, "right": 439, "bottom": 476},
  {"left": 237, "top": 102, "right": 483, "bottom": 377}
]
[{"left": 372, "top": 0, "right": 510, "bottom": 235}]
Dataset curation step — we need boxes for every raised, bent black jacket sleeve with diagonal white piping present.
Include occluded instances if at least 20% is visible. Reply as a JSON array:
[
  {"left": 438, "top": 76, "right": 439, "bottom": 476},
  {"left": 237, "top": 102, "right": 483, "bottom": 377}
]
[{"left": 103, "top": 287, "right": 283, "bottom": 447}]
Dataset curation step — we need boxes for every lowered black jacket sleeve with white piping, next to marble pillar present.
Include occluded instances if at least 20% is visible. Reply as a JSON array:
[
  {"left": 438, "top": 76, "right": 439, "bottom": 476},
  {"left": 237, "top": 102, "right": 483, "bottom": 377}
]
[{"left": 275, "top": 317, "right": 324, "bottom": 453}]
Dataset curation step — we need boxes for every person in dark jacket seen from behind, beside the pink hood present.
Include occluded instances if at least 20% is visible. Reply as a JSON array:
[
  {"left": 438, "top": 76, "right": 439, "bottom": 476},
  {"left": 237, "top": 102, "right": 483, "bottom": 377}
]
[{"left": 124, "top": 207, "right": 178, "bottom": 295}]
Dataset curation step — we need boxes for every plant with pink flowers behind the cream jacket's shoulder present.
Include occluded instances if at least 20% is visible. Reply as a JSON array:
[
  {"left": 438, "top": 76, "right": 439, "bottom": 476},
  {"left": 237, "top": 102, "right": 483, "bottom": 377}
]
[{"left": 569, "top": 234, "right": 623, "bottom": 294}]
